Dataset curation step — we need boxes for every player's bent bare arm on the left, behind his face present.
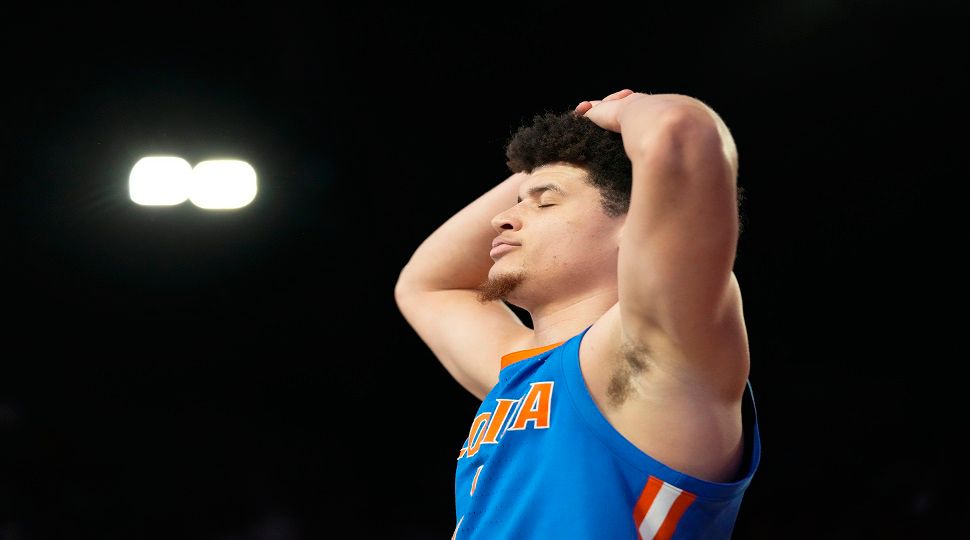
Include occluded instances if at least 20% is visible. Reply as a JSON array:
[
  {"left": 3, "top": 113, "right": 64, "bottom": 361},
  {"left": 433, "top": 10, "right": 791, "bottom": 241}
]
[{"left": 394, "top": 174, "right": 529, "bottom": 399}]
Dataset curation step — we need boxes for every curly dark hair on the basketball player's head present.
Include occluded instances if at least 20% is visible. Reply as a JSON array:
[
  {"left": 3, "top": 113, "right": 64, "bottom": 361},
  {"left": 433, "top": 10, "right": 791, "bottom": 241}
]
[{"left": 505, "top": 109, "right": 744, "bottom": 234}]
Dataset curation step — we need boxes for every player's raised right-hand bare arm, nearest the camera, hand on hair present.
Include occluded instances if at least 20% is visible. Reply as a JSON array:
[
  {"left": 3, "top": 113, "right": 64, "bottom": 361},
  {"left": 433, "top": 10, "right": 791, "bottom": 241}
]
[{"left": 577, "top": 93, "right": 748, "bottom": 401}]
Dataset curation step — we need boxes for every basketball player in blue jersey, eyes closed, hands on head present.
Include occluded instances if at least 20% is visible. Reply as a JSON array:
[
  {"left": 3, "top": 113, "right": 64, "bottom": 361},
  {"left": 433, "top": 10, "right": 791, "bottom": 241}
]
[{"left": 395, "top": 90, "right": 760, "bottom": 540}]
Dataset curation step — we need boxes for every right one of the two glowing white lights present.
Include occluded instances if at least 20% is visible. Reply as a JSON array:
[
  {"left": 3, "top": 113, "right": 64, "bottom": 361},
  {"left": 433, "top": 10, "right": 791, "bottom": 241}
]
[{"left": 189, "top": 159, "right": 256, "bottom": 210}]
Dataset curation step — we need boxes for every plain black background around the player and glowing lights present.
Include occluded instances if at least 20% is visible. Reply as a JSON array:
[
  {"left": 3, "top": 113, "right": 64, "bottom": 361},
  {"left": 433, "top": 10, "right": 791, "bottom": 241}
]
[{"left": 0, "top": 0, "right": 970, "bottom": 540}]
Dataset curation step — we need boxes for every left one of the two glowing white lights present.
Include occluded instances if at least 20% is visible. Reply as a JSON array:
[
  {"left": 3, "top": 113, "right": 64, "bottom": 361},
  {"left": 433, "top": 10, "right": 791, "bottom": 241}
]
[{"left": 128, "top": 156, "right": 192, "bottom": 206}]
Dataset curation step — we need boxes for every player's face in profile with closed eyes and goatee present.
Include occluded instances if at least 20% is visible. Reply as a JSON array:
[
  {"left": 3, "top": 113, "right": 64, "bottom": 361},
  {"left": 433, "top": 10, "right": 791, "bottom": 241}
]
[{"left": 482, "top": 164, "right": 625, "bottom": 309}]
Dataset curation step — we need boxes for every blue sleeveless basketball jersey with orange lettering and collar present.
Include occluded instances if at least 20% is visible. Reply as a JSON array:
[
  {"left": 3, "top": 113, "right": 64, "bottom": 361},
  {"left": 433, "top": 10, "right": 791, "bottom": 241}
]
[{"left": 453, "top": 327, "right": 761, "bottom": 540}]
